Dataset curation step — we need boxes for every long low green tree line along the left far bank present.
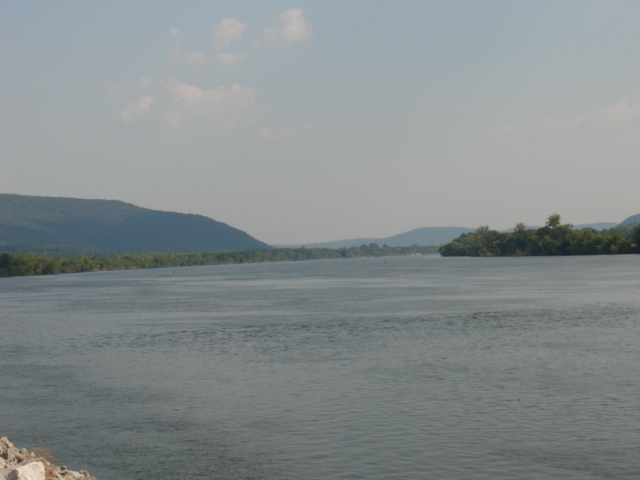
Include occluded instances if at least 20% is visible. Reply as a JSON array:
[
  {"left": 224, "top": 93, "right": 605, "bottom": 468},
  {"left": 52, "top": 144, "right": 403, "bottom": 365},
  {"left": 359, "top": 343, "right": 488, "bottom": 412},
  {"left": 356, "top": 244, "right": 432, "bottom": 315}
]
[{"left": 0, "top": 243, "right": 437, "bottom": 277}]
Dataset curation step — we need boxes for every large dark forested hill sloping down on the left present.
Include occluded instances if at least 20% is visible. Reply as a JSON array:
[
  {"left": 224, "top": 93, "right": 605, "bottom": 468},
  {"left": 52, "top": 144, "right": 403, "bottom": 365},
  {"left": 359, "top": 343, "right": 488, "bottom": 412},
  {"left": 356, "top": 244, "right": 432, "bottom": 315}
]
[{"left": 0, "top": 194, "right": 271, "bottom": 255}]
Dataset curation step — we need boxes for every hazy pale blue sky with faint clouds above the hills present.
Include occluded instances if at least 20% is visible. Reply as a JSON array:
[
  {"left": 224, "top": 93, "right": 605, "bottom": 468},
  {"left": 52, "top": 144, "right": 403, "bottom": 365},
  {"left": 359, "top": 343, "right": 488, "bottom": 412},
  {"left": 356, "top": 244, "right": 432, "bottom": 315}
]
[{"left": 0, "top": 0, "right": 640, "bottom": 244}]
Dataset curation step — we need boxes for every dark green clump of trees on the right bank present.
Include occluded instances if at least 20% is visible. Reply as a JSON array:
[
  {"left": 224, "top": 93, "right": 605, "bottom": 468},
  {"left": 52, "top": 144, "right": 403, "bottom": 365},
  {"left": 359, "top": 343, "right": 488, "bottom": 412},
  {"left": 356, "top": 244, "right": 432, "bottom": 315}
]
[{"left": 438, "top": 214, "right": 640, "bottom": 257}]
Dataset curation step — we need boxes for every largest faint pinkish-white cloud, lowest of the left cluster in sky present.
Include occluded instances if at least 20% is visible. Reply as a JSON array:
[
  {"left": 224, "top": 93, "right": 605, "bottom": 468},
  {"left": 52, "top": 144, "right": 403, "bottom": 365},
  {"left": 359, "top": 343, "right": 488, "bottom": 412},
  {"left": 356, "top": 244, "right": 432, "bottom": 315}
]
[{"left": 166, "top": 83, "right": 256, "bottom": 133}]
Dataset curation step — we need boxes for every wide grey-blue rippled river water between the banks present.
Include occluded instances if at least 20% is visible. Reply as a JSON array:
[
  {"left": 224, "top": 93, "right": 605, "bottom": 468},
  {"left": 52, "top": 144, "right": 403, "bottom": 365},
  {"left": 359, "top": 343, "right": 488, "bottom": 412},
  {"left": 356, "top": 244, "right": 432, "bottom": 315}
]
[{"left": 0, "top": 256, "right": 640, "bottom": 480}]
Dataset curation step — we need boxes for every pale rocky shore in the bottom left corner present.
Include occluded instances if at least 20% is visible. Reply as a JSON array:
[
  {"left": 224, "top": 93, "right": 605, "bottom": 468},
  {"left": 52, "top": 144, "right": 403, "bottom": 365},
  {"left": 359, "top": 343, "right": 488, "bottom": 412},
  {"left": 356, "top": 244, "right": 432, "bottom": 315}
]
[{"left": 0, "top": 437, "right": 97, "bottom": 480}]
